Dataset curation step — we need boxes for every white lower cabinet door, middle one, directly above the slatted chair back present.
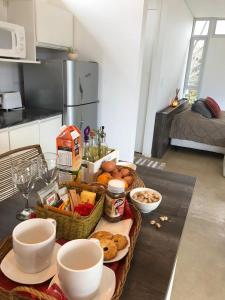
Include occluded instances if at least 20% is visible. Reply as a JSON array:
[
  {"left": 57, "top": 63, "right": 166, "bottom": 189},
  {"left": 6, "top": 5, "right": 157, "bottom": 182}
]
[{"left": 9, "top": 122, "right": 39, "bottom": 150}]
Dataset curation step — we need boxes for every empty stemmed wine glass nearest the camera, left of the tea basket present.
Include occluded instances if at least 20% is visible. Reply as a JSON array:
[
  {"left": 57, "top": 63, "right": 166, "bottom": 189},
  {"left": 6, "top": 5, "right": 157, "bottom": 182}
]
[{"left": 12, "top": 160, "right": 37, "bottom": 221}]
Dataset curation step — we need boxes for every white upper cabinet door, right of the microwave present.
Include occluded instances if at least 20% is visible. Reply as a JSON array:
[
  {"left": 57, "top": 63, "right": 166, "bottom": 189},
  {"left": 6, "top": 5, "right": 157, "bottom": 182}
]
[{"left": 35, "top": 0, "right": 73, "bottom": 48}]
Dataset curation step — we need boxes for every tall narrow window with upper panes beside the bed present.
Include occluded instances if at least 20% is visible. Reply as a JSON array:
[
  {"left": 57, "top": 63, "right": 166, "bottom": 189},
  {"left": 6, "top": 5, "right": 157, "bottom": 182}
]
[{"left": 183, "top": 18, "right": 225, "bottom": 103}]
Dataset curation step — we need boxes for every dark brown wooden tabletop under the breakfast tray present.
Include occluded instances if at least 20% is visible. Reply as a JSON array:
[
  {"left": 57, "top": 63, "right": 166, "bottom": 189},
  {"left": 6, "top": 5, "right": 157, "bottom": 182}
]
[{"left": 0, "top": 167, "right": 195, "bottom": 300}]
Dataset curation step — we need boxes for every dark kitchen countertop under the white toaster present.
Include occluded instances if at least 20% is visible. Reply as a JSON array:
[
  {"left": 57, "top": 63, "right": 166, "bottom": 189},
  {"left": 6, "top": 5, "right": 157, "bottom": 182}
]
[{"left": 0, "top": 108, "right": 62, "bottom": 129}]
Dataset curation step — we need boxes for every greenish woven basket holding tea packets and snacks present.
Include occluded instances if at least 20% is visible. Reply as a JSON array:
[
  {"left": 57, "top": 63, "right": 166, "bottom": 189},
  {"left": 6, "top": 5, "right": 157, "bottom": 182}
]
[{"left": 36, "top": 182, "right": 105, "bottom": 240}]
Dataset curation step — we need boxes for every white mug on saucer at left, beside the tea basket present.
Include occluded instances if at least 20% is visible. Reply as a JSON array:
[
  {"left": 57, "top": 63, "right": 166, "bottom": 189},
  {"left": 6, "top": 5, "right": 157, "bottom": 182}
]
[{"left": 12, "top": 218, "right": 56, "bottom": 274}]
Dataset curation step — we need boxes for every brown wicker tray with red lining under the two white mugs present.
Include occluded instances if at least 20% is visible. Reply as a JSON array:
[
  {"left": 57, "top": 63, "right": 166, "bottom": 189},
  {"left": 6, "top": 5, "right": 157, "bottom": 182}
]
[{"left": 0, "top": 205, "right": 141, "bottom": 300}]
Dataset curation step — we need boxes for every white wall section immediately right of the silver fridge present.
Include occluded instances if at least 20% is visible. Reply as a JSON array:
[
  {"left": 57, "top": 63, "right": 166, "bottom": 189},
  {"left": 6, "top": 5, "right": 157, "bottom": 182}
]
[{"left": 64, "top": 0, "right": 144, "bottom": 161}]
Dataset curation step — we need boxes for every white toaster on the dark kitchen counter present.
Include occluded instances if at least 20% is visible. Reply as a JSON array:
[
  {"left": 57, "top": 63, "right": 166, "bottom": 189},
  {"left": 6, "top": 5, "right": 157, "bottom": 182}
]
[{"left": 0, "top": 92, "right": 23, "bottom": 110}]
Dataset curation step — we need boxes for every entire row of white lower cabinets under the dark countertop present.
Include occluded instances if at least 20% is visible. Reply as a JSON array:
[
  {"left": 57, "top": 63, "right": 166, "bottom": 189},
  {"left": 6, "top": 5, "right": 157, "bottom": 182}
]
[{"left": 0, "top": 115, "right": 62, "bottom": 154}]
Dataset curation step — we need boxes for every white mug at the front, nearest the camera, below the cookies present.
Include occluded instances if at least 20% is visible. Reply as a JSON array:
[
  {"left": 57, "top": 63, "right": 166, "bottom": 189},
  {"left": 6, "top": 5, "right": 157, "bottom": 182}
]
[{"left": 57, "top": 239, "right": 103, "bottom": 300}]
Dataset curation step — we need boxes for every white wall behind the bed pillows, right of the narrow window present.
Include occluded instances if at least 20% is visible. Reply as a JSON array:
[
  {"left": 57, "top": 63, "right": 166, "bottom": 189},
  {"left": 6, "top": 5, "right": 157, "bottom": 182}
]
[{"left": 200, "top": 37, "right": 225, "bottom": 110}]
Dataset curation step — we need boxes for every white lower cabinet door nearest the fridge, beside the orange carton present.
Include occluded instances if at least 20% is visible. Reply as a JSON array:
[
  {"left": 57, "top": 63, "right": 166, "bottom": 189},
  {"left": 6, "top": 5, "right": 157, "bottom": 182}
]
[{"left": 40, "top": 116, "right": 62, "bottom": 153}]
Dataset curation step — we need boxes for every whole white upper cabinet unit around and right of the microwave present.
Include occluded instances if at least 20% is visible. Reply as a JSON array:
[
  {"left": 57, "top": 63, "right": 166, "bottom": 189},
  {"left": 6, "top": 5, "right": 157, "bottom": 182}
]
[{"left": 7, "top": 0, "right": 73, "bottom": 62}]
